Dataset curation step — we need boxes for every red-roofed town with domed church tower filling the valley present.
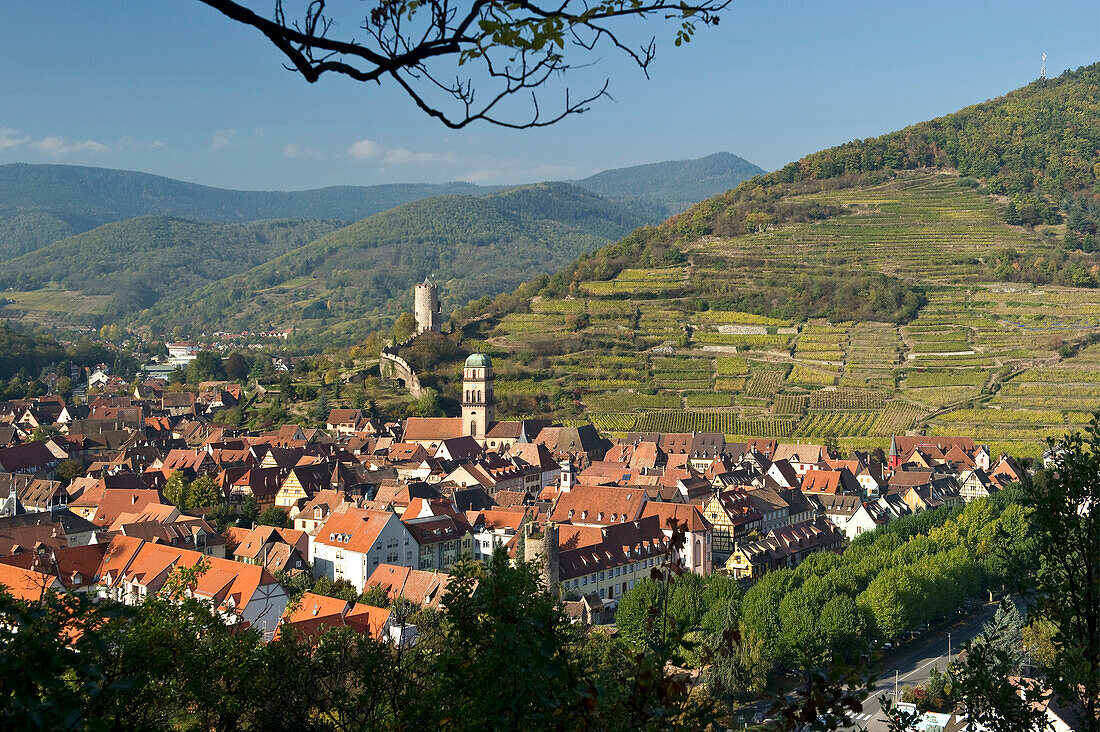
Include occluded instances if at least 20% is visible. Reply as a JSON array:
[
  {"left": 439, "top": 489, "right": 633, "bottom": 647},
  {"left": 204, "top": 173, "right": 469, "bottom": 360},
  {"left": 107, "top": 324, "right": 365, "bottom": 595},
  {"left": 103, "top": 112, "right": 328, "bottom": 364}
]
[{"left": 0, "top": 272, "right": 1082, "bottom": 717}]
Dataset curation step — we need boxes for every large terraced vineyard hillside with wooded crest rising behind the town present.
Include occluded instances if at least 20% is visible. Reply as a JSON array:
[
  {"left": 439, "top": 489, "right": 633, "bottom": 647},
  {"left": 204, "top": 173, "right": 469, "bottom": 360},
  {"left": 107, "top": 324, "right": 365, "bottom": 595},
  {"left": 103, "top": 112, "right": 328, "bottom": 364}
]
[{"left": 437, "top": 66, "right": 1100, "bottom": 454}]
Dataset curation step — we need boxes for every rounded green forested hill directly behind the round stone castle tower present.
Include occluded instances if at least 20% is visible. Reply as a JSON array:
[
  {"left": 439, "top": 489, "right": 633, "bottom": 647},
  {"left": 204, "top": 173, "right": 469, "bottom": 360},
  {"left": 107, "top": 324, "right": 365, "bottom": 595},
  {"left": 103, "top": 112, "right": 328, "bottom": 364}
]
[{"left": 127, "top": 183, "right": 644, "bottom": 345}]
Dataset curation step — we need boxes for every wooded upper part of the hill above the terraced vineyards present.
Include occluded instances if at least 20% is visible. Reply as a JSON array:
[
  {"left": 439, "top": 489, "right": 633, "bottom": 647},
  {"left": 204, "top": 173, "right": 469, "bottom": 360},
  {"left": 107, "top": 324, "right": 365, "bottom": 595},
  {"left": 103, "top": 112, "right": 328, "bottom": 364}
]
[{"left": 541, "top": 64, "right": 1100, "bottom": 301}]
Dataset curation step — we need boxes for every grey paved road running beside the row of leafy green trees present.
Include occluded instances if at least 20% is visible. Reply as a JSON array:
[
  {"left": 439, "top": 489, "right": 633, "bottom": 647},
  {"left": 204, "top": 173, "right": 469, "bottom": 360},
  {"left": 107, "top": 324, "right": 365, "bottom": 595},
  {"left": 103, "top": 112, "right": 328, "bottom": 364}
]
[{"left": 843, "top": 602, "right": 997, "bottom": 732}]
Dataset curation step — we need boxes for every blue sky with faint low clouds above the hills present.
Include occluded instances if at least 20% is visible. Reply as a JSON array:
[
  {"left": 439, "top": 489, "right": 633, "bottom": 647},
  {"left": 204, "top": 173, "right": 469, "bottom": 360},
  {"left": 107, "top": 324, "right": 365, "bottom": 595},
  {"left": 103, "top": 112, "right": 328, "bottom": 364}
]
[{"left": 0, "top": 0, "right": 1100, "bottom": 190}]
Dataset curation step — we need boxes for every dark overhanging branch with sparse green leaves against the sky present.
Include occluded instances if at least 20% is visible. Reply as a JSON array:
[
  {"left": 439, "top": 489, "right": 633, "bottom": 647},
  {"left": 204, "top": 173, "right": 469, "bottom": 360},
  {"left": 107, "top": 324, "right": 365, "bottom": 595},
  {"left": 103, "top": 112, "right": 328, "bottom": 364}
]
[{"left": 200, "top": 0, "right": 730, "bottom": 130}]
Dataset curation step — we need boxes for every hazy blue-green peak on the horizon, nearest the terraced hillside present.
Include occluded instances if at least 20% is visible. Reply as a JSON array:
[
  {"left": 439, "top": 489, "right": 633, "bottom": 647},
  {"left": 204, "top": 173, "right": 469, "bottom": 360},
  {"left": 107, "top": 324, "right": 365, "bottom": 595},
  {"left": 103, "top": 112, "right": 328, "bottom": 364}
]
[{"left": 574, "top": 153, "right": 765, "bottom": 220}]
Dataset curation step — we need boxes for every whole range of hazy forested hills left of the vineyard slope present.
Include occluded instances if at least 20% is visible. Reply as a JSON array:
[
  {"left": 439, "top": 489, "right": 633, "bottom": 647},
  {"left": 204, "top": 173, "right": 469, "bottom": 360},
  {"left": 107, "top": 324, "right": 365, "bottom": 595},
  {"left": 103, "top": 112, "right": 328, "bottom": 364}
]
[{"left": 0, "top": 153, "right": 762, "bottom": 332}]
